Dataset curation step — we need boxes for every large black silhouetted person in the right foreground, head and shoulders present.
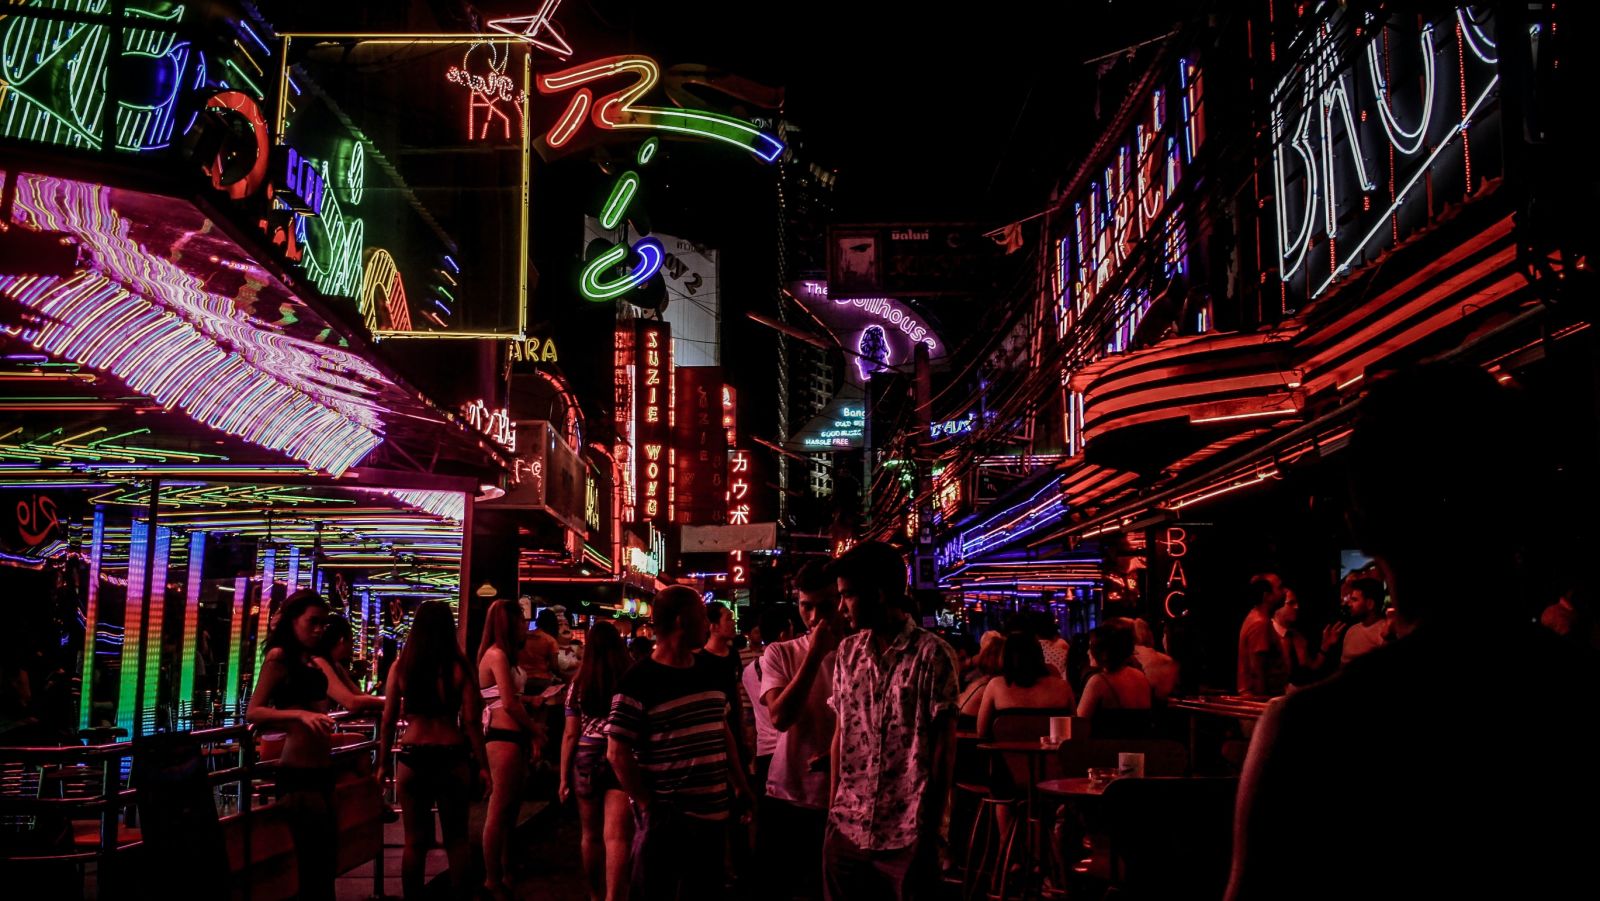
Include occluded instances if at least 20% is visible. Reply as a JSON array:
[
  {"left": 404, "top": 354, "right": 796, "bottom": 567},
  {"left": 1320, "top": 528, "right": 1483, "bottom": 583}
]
[{"left": 1227, "top": 366, "right": 1600, "bottom": 901}]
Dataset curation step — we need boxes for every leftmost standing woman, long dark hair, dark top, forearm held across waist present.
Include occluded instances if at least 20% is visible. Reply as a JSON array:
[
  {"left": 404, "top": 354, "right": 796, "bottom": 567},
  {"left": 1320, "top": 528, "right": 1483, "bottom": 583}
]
[{"left": 245, "top": 591, "right": 338, "bottom": 899}]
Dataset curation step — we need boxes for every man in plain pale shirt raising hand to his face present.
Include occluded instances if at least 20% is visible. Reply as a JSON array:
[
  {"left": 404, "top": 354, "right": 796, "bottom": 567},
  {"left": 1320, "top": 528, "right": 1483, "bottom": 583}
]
[{"left": 758, "top": 562, "right": 848, "bottom": 898}]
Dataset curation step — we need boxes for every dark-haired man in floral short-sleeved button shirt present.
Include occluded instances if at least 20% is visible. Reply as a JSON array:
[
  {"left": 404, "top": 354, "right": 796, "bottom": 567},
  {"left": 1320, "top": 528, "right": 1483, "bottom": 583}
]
[{"left": 822, "top": 541, "right": 957, "bottom": 901}]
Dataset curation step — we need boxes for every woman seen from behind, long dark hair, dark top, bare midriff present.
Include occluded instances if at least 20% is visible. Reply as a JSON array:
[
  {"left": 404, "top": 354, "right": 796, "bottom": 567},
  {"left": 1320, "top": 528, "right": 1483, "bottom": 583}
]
[{"left": 378, "top": 600, "right": 490, "bottom": 898}]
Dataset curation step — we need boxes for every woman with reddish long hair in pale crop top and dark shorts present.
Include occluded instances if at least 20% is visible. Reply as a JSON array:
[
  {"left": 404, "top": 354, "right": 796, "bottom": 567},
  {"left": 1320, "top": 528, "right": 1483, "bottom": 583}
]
[{"left": 478, "top": 599, "right": 538, "bottom": 898}]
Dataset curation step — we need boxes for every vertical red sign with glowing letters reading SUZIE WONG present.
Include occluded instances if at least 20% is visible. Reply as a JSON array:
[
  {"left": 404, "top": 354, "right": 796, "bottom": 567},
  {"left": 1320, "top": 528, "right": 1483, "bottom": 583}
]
[{"left": 634, "top": 320, "right": 674, "bottom": 525}]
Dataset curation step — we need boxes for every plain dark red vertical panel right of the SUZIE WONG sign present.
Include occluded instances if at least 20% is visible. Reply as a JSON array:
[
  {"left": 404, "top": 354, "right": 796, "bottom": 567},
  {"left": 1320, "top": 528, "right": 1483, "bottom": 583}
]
[{"left": 672, "top": 366, "right": 728, "bottom": 525}]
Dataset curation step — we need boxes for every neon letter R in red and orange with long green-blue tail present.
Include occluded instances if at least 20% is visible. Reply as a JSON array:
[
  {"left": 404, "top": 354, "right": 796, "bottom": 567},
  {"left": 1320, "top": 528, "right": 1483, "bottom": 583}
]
[{"left": 539, "top": 56, "right": 784, "bottom": 163}]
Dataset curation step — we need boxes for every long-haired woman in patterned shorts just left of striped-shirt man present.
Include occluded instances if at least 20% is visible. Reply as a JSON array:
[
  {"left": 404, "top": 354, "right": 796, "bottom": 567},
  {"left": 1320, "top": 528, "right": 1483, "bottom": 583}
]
[{"left": 560, "top": 623, "right": 634, "bottom": 901}]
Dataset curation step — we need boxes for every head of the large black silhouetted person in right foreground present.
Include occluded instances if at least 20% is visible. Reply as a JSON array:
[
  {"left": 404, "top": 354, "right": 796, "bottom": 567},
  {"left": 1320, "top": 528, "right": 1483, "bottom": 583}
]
[{"left": 1346, "top": 363, "right": 1536, "bottom": 627}]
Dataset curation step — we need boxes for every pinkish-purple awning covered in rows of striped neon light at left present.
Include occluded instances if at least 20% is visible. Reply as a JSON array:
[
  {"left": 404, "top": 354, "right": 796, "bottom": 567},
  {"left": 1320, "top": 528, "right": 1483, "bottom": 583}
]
[{"left": 0, "top": 176, "right": 384, "bottom": 475}]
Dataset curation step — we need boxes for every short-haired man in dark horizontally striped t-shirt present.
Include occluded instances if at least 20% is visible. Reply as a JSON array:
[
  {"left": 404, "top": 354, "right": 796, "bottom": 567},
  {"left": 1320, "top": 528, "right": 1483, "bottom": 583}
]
[{"left": 606, "top": 586, "right": 750, "bottom": 901}]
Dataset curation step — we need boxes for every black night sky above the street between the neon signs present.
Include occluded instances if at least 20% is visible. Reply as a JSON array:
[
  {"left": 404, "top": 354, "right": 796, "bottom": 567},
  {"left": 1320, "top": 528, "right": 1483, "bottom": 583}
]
[{"left": 505, "top": 0, "right": 1194, "bottom": 222}]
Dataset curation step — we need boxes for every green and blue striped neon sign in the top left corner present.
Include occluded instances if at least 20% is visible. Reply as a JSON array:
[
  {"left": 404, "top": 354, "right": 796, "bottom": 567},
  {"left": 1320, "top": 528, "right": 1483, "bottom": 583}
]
[{"left": 0, "top": 0, "right": 192, "bottom": 152}]
